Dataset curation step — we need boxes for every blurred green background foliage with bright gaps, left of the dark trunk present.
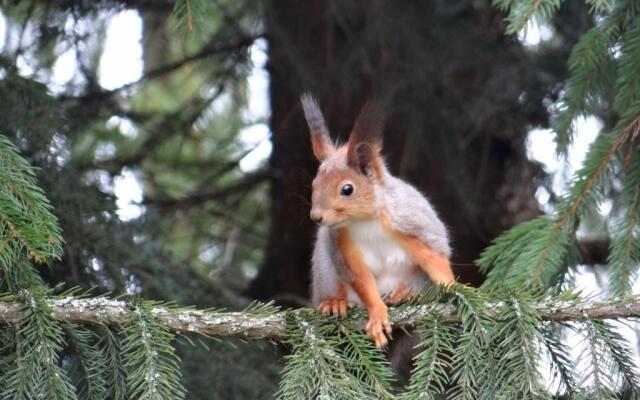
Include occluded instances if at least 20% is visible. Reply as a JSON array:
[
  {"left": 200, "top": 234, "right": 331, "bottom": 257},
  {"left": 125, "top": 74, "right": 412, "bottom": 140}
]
[{"left": 0, "top": 1, "right": 280, "bottom": 399}]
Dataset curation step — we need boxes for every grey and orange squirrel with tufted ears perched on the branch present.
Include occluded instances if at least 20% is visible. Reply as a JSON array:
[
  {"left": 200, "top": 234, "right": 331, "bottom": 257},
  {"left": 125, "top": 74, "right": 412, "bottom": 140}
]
[{"left": 300, "top": 94, "right": 455, "bottom": 348}]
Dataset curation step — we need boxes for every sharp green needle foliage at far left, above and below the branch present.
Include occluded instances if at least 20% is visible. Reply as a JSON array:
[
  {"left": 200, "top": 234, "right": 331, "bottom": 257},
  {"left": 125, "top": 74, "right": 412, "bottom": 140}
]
[{"left": 0, "top": 136, "right": 184, "bottom": 400}]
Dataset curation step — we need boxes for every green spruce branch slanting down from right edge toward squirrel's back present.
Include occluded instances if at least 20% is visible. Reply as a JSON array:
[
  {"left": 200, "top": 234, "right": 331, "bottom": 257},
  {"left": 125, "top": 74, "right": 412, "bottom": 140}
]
[{"left": 477, "top": 113, "right": 640, "bottom": 287}]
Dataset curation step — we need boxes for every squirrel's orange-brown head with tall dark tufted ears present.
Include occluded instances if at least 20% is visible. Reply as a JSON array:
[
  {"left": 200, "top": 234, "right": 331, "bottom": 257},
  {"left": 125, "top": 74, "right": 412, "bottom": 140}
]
[{"left": 301, "top": 95, "right": 385, "bottom": 226}]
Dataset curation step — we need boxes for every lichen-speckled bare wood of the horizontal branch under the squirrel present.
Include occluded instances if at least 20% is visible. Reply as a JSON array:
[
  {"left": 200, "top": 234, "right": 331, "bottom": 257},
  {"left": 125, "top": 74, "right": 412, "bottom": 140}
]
[{"left": 0, "top": 296, "right": 640, "bottom": 340}]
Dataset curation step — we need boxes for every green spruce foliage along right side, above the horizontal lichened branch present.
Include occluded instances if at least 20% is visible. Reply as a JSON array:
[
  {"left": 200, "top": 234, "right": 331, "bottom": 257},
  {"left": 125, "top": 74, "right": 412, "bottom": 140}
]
[{"left": 478, "top": 0, "right": 640, "bottom": 294}]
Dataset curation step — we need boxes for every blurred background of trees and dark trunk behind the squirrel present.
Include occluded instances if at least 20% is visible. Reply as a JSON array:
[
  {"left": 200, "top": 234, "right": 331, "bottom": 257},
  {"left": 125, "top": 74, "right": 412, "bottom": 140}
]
[{"left": 0, "top": 0, "right": 619, "bottom": 399}]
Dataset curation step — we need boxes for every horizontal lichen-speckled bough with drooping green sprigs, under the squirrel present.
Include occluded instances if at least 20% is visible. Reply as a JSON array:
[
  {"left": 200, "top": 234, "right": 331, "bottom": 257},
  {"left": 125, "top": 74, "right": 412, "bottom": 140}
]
[{"left": 0, "top": 286, "right": 640, "bottom": 399}]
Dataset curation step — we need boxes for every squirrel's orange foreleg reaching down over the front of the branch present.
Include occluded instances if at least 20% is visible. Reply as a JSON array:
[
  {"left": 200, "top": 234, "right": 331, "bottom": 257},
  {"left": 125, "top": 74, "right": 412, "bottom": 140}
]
[{"left": 338, "top": 228, "right": 391, "bottom": 348}]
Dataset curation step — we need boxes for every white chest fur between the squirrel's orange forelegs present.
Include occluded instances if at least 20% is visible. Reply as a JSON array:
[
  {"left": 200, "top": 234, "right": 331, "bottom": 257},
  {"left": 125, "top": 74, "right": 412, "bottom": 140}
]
[{"left": 348, "top": 221, "right": 415, "bottom": 284}]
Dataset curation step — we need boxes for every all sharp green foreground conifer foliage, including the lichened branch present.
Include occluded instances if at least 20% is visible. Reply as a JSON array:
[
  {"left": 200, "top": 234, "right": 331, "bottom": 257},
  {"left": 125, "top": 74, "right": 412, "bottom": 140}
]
[{"left": 0, "top": 0, "right": 640, "bottom": 400}]
